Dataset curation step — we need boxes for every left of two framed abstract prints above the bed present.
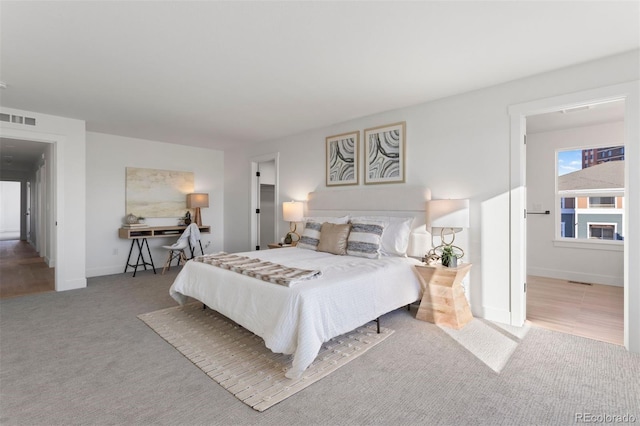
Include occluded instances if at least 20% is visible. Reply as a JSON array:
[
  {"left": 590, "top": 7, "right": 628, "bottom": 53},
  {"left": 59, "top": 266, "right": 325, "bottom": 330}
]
[{"left": 326, "top": 130, "right": 360, "bottom": 186}]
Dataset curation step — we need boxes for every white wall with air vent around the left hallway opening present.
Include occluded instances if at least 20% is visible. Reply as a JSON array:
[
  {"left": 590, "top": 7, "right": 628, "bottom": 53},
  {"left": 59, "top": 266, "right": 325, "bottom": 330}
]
[{"left": 0, "top": 108, "right": 87, "bottom": 291}]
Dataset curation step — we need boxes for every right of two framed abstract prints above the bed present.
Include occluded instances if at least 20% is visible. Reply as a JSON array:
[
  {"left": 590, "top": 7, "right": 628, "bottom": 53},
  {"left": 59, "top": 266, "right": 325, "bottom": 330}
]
[{"left": 364, "top": 121, "right": 406, "bottom": 185}]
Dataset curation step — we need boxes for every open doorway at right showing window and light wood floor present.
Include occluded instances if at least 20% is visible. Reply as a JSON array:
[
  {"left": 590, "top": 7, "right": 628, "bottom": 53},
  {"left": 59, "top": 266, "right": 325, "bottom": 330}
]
[{"left": 526, "top": 100, "right": 625, "bottom": 345}]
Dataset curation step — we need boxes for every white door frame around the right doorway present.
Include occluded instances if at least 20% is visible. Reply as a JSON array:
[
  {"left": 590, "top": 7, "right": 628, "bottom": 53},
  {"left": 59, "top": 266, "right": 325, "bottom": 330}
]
[{"left": 509, "top": 81, "right": 640, "bottom": 352}]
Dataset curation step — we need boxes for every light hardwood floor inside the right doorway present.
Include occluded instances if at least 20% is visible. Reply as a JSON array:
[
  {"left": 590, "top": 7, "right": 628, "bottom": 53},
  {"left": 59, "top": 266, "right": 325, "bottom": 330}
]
[{"left": 527, "top": 276, "right": 624, "bottom": 345}]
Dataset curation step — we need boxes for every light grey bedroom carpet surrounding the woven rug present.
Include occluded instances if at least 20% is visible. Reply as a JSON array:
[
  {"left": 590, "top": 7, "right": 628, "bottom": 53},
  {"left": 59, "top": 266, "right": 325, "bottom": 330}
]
[{"left": 0, "top": 268, "right": 640, "bottom": 426}]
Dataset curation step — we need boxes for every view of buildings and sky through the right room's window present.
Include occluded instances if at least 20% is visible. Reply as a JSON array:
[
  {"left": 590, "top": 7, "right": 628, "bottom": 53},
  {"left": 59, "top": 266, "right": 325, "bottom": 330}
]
[{"left": 556, "top": 146, "right": 624, "bottom": 240}]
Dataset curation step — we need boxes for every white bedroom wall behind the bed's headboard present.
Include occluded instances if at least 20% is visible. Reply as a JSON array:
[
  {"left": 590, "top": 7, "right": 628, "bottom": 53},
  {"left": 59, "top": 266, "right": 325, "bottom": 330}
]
[{"left": 225, "top": 51, "right": 640, "bottom": 322}]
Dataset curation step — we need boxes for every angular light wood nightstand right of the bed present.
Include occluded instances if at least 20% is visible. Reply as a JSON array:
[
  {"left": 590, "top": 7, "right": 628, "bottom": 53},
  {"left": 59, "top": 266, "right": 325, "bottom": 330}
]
[{"left": 415, "top": 263, "right": 473, "bottom": 330}]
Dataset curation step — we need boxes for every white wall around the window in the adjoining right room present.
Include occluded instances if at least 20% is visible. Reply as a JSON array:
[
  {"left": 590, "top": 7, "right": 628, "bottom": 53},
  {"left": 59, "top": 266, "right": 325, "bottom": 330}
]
[{"left": 527, "top": 122, "right": 626, "bottom": 286}]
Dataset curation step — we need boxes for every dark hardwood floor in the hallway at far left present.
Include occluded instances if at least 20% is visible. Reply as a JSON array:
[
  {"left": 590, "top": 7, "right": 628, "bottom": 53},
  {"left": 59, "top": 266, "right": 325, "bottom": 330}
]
[{"left": 0, "top": 240, "right": 55, "bottom": 299}]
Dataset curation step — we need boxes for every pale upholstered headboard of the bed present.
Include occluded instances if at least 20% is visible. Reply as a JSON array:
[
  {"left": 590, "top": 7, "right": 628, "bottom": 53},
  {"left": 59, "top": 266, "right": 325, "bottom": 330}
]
[{"left": 305, "top": 185, "right": 431, "bottom": 256}]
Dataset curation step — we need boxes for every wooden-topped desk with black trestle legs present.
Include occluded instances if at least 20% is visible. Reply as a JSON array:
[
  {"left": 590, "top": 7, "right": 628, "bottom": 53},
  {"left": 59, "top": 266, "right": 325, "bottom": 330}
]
[{"left": 118, "top": 225, "right": 211, "bottom": 277}]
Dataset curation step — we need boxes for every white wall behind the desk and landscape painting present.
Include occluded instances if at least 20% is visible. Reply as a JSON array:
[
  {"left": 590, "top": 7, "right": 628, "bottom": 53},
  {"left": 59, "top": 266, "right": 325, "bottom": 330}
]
[{"left": 86, "top": 132, "right": 224, "bottom": 277}]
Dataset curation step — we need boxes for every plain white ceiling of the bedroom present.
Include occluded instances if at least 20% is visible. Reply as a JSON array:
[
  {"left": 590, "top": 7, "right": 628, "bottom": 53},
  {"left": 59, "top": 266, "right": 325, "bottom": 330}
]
[{"left": 0, "top": 1, "right": 640, "bottom": 154}]
